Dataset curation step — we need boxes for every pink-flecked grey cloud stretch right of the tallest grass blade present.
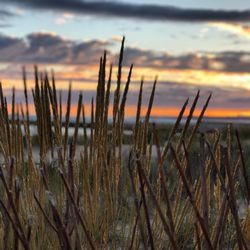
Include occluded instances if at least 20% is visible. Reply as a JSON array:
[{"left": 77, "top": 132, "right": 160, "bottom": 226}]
[{"left": 121, "top": 48, "right": 250, "bottom": 73}]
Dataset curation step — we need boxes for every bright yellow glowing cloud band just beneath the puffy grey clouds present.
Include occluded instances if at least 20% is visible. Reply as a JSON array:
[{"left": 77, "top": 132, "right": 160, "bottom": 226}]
[{"left": 1, "top": 66, "right": 250, "bottom": 90}]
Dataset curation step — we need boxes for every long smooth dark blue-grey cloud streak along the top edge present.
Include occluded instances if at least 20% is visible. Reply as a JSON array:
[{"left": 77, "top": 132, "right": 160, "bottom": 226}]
[{"left": 0, "top": 0, "right": 250, "bottom": 22}]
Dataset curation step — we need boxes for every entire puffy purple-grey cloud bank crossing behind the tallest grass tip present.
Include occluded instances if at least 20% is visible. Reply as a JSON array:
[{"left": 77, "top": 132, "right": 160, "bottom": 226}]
[{"left": 0, "top": 32, "right": 250, "bottom": 73}]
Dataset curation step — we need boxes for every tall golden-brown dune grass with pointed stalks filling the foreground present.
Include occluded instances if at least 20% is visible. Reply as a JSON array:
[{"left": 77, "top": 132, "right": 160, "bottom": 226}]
[{"left": 0, "top": 39, "right": 250, "bottom": 249}]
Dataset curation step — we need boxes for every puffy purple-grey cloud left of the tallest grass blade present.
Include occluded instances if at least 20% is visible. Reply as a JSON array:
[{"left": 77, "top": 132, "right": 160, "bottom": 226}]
[{"left": 0, "top": 32, "right": 109, "bottom": 65}]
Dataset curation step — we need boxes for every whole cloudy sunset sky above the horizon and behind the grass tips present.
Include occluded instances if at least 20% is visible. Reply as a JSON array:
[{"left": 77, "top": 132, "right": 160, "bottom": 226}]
[{"left": 0, "top": 0, "right": 250, "bottom": 117}]
